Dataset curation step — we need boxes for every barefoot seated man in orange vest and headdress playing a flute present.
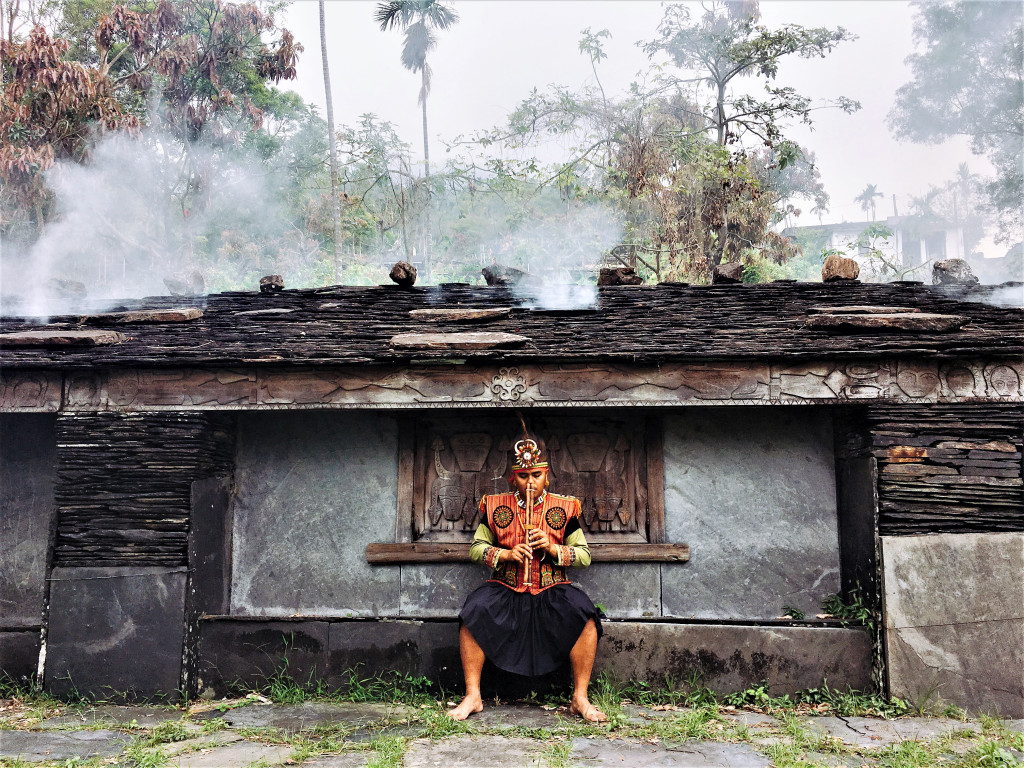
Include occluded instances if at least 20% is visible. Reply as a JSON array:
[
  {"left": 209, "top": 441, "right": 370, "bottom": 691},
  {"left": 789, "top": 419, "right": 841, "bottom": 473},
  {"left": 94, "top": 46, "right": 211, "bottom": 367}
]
[{"left": 450, "top": 437, "right": 607, "bottom": 723}]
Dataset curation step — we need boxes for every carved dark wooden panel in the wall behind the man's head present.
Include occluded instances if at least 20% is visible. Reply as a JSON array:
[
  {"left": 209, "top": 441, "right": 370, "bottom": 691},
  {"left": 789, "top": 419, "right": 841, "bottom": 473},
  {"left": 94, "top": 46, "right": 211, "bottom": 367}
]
[{"left": 399, "top": 414, "right": 664, "bottom": 544}]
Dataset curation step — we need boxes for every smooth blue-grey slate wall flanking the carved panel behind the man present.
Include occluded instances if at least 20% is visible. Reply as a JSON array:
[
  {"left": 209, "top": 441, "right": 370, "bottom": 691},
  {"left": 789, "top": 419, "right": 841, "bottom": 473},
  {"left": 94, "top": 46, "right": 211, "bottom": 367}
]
[{"left": 231, "top": 408, "right": 840, "bottom": 620}]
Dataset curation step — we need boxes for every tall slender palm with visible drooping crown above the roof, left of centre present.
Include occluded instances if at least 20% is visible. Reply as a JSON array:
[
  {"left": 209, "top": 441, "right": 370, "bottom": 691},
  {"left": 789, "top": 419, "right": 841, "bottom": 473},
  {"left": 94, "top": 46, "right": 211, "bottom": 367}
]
[{"left": 375, "top": 0, "right": 459, "bottom": 278}]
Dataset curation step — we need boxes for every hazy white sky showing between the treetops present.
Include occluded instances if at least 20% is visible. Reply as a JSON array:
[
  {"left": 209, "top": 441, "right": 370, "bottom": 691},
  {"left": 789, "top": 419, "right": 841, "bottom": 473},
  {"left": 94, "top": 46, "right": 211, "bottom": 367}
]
[{"left": 279, "top": 0, "right": 988, "bottom": 224}]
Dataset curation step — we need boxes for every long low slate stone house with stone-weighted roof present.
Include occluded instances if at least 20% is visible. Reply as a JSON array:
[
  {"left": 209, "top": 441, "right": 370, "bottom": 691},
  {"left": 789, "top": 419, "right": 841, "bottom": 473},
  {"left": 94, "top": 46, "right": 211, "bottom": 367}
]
[{"left": 0, "top": 282, "right": 1024, "bottom": 717}]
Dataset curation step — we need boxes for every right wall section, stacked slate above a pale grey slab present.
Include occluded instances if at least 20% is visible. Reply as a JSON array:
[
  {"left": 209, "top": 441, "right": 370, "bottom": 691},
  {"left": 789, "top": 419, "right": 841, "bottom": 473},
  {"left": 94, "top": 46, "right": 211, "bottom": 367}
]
[{"left": 868, "top": 402, "right": 1024, "bottom": 718}]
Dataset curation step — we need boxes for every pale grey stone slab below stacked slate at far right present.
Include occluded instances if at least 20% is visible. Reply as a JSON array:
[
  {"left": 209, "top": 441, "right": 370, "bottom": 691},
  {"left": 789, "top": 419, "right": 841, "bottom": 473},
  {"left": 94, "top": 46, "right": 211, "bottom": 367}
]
[{"left": 882, "top": 534, "right": 1024, "bottom": 718}]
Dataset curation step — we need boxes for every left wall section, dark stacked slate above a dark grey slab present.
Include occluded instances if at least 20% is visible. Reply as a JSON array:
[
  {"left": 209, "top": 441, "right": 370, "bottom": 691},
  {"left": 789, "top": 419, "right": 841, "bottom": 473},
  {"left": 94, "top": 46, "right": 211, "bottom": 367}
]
[{"left": 44, "top": 413, "right": 234, "bottom": 699}]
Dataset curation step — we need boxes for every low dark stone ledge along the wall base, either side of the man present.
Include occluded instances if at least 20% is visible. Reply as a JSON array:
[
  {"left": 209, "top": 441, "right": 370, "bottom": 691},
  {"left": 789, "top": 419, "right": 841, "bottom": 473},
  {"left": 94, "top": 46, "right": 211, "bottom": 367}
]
[{"left": 200, "top": 618, "right": 871, "bottom": 695}]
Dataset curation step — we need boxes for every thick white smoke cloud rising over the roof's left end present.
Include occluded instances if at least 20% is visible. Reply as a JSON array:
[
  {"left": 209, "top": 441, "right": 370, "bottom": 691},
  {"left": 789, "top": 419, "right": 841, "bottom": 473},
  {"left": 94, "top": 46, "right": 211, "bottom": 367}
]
[{"left": 0, "top": 129, "right": 318, "bottom": 317}]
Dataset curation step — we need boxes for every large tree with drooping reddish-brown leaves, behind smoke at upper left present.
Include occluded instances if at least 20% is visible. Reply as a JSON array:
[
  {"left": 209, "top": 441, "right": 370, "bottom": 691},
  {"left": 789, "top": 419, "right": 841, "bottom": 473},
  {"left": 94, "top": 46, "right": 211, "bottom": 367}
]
[{"left": 0, "top": 0, "right": 311, "bottom": 288}]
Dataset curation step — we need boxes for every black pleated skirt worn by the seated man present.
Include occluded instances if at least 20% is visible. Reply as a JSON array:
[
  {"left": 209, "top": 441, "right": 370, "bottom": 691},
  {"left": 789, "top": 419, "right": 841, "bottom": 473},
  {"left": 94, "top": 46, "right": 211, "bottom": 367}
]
[{"left": 459, "top": 582, "right": 601, "bottom": 677}]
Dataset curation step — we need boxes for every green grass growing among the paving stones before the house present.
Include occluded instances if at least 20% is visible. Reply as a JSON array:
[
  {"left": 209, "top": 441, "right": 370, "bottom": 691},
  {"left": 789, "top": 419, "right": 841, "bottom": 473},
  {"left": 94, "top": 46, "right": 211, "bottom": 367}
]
[{"left": 6, "top": 671, "right": 1024, "bottom": 768}]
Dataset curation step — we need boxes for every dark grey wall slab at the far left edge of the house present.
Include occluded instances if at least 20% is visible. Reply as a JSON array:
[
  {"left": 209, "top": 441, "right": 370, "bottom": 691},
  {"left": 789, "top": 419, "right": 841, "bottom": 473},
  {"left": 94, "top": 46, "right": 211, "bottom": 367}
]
[{"left": 0, "top": 414, "right": 56, "bottom": 629}]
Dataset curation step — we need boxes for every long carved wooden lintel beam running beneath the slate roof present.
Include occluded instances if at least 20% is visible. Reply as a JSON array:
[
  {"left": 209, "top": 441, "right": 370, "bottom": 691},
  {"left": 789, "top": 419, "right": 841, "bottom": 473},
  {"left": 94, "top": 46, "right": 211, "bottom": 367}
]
[{"left": 0, "top": 359, "right": 1024, "bottom": 412}]
